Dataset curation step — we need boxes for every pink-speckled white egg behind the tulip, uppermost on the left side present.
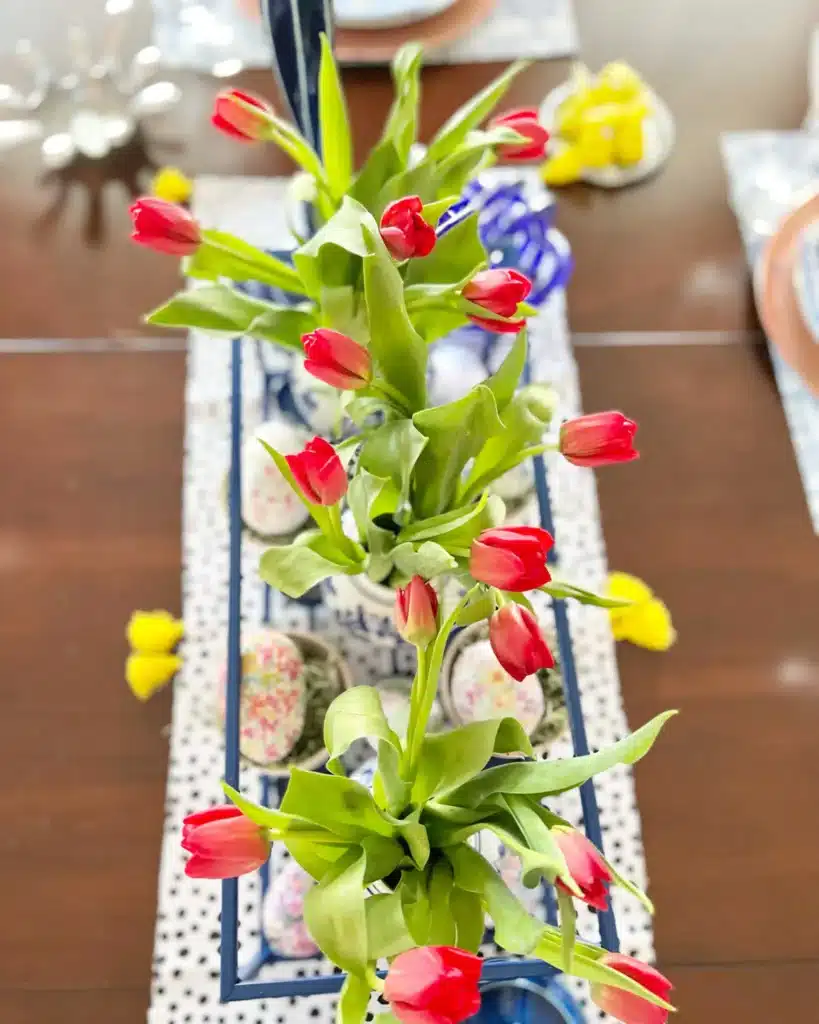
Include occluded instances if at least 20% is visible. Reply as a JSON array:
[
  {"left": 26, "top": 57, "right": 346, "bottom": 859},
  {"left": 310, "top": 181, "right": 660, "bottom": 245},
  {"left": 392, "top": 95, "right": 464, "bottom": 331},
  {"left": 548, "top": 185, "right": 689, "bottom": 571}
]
[{"left": 242, "top": 420, "right": 310, "bottom": 537}]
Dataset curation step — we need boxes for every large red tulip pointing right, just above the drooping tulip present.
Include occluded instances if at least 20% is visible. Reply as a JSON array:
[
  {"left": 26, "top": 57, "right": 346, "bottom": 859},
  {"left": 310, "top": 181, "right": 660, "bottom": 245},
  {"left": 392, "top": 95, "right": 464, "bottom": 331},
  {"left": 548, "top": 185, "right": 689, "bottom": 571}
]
[{"left": 469, "top": 526, "right": 555, "bottom": 592}]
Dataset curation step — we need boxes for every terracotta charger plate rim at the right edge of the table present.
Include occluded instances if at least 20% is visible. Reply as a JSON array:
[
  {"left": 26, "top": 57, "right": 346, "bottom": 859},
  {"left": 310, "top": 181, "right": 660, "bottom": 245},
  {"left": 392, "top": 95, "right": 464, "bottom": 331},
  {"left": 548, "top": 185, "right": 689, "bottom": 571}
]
[{"left": 755, "top": 195, "right": 819, "bottom": 396}]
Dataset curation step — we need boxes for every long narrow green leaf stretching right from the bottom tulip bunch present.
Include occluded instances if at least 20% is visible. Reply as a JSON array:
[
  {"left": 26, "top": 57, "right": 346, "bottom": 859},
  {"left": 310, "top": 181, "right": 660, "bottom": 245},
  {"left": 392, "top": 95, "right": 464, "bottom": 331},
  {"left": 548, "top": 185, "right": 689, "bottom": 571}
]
[{"left": 443, "top": 711, "right": 677, "bottom": 807}]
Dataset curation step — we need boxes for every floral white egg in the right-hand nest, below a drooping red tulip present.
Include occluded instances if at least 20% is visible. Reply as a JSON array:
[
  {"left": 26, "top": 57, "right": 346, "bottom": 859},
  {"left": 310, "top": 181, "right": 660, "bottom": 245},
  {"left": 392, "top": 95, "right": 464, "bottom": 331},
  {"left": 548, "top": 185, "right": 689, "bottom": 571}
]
[{"left": 449, "top": 640, "right": 546, "bottom": 734}]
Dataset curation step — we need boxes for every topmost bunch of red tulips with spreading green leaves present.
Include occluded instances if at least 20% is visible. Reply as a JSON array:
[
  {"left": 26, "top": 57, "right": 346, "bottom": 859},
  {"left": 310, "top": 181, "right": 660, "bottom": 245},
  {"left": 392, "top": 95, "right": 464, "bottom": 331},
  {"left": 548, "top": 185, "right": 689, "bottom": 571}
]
[{"left": 131, "top": 39, "right": 548, "bottom": 358}]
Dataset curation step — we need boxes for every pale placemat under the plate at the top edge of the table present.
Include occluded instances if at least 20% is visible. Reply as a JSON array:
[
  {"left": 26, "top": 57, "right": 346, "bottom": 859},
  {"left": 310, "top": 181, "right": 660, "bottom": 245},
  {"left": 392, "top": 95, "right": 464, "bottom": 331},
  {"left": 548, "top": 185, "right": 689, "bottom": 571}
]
[{"left": 154, "top": 0, "right": 578, "bottom": 72}]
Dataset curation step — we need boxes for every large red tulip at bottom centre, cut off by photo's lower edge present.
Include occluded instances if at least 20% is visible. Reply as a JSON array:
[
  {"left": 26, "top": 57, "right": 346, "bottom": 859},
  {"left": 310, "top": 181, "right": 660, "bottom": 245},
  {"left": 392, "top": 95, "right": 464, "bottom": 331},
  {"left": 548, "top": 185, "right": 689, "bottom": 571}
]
[{"left": 384, "top": 946, "right": 483, "bottom": 1024}]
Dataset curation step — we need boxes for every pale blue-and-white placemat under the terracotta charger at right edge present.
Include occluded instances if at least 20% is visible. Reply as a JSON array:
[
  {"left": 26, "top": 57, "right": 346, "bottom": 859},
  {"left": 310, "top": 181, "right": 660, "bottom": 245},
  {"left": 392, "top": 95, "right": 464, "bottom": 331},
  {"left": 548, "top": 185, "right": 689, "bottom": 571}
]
[{"left": 721, "top": 131, "right": 819, "bottom": 534}]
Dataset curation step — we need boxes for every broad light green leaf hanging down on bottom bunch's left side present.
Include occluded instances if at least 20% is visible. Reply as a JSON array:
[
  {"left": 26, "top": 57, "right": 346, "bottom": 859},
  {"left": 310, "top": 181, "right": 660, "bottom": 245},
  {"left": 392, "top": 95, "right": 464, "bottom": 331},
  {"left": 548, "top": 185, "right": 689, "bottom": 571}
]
[{"left": 304, "top": 849, "right": 369, "bottom": 974}]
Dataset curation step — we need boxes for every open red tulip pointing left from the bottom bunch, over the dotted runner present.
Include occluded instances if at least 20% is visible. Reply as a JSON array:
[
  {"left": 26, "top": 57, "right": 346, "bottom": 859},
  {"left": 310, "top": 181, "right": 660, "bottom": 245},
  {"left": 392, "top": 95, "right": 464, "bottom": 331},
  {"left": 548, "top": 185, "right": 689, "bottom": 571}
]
[{"left": 182, "top": 804, "right": 270, "bottom": 879}]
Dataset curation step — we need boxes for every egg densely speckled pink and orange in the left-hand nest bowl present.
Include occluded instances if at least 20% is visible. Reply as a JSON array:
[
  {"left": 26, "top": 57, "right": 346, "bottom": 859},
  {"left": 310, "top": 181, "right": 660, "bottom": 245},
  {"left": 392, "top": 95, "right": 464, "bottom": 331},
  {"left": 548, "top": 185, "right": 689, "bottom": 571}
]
[{"left": 219, "top": 629, "right": 307, "bottom": 767}]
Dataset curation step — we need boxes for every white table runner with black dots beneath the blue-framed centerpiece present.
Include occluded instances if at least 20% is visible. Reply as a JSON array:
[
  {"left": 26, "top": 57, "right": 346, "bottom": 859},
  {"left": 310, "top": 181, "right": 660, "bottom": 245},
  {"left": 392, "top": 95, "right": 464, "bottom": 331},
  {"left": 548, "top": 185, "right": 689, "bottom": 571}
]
[{"left": 148, "top": 178, "right": 652, "bottom": 1024}]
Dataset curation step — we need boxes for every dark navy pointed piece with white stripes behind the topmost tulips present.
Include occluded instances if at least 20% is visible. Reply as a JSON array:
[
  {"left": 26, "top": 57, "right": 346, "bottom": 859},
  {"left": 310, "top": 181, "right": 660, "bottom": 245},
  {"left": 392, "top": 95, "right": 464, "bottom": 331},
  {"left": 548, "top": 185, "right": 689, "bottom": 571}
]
[{"left": 262, "top": 0, "right": 333, "bottom": 151}]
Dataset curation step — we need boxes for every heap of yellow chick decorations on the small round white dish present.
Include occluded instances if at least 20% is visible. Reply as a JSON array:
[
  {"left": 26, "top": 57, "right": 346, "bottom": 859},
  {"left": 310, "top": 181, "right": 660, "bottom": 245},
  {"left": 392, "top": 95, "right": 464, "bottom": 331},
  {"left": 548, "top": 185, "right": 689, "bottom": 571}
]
[{"left": 542, "top": 60, "right": 652, "bottom": 185}]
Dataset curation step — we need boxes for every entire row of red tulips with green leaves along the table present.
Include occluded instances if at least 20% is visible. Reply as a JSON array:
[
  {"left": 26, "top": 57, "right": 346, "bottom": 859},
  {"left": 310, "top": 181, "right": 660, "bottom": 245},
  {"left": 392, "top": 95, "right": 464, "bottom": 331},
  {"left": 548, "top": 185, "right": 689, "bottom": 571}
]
[{"left": 134, "top": 32, "right": 674, "bottom": 1024}]
